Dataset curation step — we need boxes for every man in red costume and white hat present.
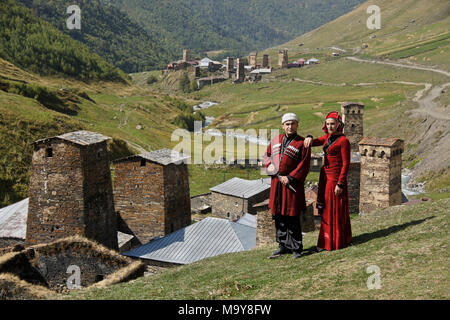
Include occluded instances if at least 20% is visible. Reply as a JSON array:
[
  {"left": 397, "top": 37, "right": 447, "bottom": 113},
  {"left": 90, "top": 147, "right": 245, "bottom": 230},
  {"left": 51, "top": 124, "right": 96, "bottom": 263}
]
[{"left": 264, "top": 113, "right": 311, "bottom": 259}]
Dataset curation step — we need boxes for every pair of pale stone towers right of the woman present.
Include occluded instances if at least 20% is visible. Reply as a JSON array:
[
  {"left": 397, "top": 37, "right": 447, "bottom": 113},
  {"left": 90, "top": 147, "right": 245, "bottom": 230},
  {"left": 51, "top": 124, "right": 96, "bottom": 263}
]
[{"left": 341, "top": 102, "right": 404, "bottom": 214}]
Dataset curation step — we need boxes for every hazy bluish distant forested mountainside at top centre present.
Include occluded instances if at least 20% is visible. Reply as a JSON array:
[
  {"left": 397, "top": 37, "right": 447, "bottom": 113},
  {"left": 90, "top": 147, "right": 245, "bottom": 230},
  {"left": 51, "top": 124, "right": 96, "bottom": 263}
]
[{"left": 101, "top": 0, "right": 364, "bottom": 57}]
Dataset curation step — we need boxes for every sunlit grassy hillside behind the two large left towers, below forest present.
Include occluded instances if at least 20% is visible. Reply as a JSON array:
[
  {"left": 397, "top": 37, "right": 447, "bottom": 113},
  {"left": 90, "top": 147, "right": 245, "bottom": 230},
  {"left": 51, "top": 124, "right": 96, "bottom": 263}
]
[{"left": 0, "top": 59, "right": 197, "bottom": 207}]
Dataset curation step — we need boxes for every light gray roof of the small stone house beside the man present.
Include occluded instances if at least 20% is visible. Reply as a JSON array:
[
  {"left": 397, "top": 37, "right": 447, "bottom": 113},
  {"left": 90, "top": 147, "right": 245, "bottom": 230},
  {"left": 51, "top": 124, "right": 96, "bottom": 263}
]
[{"left": 209, "top": 177, "right": 270, "bottom": 199}]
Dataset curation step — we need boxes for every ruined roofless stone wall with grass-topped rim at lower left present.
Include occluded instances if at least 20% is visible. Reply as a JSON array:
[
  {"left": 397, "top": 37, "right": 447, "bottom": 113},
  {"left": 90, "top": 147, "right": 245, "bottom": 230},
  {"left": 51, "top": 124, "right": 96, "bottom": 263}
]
[{"left": 0, "top": 238, "right": 145, "bottom": 292}]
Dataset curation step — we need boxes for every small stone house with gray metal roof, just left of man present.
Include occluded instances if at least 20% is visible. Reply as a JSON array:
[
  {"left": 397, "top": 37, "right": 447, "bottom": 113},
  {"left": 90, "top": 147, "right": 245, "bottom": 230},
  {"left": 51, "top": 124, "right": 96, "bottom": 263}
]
[{"left": 210, "top": 177, "right": 270, "bottom": 220}]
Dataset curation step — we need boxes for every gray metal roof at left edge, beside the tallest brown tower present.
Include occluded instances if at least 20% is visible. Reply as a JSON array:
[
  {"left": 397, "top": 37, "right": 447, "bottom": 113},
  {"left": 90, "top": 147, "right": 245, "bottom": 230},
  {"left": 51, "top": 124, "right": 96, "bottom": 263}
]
[{"left": 0, "top": 198, "right": 28, "bottom": 239}]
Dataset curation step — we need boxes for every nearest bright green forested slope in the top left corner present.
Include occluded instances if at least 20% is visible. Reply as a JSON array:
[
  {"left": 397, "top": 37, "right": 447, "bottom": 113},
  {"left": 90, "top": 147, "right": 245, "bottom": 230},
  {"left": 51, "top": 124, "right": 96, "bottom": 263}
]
[{"left": 0, "top": 0, "right": 126, "bottom": 82}]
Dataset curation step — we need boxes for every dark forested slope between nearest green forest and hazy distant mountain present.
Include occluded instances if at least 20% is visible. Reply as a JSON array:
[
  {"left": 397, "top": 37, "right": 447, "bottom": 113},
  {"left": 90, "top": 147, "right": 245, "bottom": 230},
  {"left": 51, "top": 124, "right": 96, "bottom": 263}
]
[{"left": 18, "top": 0, "right": 173, "bottom": 73}]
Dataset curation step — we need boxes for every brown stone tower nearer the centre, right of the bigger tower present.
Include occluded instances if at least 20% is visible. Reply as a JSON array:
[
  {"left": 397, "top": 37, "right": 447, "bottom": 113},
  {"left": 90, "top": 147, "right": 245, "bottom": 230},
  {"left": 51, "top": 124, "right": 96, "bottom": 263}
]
[{"left": 114, "top": 149, "right": 191, "bottom": 243}]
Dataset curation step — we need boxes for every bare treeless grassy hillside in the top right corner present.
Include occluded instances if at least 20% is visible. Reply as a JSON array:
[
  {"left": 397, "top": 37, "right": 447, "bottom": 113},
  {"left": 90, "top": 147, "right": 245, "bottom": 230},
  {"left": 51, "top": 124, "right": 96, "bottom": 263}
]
[{"left": 268, "top": 0, "right": 450, "bottom": 71}]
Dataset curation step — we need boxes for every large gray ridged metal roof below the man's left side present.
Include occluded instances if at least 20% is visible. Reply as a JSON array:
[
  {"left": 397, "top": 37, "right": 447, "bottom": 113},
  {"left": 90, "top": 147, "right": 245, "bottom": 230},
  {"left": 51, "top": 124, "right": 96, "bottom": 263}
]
[{"left": 123, "top": 217, "right": 256, "bottom": 264}]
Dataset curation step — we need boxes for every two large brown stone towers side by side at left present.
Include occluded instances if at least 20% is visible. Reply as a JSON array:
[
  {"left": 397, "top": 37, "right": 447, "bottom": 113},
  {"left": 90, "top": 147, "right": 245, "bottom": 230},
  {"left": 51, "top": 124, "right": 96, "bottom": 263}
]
[{"left": 26, "top": 131, "right": 191, "bottom": 249}]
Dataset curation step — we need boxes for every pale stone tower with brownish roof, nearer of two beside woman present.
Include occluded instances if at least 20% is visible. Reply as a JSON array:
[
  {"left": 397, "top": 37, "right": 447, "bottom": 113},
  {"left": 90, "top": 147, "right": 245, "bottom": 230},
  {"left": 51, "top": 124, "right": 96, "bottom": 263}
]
[{"left": 359, "top": 137, "right": 404, "bottom": 213}]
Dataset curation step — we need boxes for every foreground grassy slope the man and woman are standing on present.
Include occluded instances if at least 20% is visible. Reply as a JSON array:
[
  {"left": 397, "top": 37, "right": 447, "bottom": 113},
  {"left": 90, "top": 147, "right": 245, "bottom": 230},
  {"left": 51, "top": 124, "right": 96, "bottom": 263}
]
[{"left": 64, "top": 199, "right": 450, "bottom": 300}]
